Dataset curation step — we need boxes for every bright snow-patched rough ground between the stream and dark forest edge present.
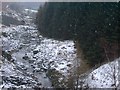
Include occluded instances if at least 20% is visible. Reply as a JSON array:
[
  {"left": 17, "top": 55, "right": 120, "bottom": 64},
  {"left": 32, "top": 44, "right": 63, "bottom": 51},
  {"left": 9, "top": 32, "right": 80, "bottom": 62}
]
[{"left": 32, "top": 39, "right": 76, "bottom": 74}]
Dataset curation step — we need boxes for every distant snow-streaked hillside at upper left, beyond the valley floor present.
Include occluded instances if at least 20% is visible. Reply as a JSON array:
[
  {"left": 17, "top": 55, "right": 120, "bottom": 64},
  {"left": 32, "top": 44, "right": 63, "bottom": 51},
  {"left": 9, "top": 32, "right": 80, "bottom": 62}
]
[{"left": 0, "top": 3, "right": 37, "bottom": 26}]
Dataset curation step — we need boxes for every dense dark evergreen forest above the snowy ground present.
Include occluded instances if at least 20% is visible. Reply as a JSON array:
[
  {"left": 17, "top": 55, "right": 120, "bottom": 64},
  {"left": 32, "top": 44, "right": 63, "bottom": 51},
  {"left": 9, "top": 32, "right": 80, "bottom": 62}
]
[{"left": 36, "top": 2, "right": 120, "bottom": 65}]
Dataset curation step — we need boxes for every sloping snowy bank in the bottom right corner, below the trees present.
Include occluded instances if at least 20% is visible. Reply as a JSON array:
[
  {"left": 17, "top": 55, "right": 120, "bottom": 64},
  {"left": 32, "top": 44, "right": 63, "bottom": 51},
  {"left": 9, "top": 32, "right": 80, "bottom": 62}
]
[{"left": 79, "top": 58, "right": 120, "bottom": 89}]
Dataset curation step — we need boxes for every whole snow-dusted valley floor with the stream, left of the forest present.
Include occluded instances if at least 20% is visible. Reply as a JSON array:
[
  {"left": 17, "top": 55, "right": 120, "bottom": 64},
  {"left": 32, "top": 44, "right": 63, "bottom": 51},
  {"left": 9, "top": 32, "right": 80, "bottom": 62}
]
[{"left": 0, "top": 25, "right": 76, "bottom": 88}]
